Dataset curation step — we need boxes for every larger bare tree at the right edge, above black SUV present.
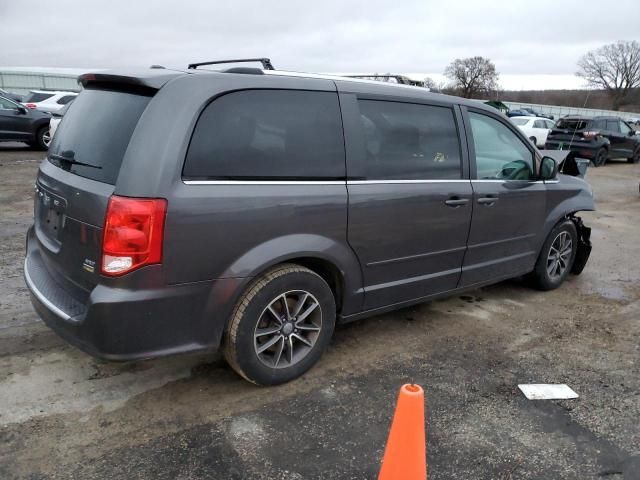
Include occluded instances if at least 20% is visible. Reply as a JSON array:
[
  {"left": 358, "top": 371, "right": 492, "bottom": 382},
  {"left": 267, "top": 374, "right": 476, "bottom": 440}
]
[{"left": 576, "top": 40, "right": 640, "bottom": 110}]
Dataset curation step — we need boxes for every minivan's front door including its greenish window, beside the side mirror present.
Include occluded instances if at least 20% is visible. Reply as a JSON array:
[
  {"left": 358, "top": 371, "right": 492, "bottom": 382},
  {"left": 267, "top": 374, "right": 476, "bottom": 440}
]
[{"left": 460, "top": 110, "right": 546, "bottom": 287}]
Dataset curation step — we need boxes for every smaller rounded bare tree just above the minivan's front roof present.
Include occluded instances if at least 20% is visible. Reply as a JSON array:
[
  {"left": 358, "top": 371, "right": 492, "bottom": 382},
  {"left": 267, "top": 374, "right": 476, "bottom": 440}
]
[{"left": 444, "top": 57, "right": 498, "bottom": 98}]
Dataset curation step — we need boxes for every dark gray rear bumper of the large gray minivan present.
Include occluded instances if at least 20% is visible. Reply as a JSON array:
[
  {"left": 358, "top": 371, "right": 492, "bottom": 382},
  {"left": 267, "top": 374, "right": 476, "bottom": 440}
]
[{"left": 24, "top": 230, "right": 239, "bottom": 360}]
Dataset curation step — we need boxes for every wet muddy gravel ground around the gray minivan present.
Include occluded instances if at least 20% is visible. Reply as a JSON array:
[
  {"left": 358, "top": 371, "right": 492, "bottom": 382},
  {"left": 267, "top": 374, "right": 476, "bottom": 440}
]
[{"left": 0, "top": 144, "right": 640, "bottom": 480}]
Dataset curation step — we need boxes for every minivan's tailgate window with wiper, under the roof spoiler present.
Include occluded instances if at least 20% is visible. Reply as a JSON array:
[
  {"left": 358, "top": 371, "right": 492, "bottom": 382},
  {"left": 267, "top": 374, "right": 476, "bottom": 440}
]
[{"left": 48, "top": 89, "right": 151, "bottom": 185}]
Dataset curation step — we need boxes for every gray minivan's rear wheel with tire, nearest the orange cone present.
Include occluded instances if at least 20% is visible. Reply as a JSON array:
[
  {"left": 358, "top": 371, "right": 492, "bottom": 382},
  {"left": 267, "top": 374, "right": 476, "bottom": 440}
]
[{"left": 223, "top": 264, "right": 336, "bottom": 385}]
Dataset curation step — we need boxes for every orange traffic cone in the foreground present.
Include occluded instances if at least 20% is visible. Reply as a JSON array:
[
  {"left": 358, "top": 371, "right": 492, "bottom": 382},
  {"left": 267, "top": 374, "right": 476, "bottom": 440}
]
[{"left": 378, "top": 384, "right": 427, "bottom": 480}]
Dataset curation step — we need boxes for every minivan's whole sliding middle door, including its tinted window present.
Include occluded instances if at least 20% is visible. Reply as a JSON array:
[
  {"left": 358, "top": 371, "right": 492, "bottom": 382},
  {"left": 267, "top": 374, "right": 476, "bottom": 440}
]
[{"left": 340, "top": 94, "right": 473, "bottom": 310}]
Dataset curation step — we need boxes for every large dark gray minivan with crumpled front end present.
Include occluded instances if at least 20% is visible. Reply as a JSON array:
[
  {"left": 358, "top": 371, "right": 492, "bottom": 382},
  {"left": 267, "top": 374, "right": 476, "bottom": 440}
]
[{"left": 24, "top": 62, "right": 594, "bottom": 384}]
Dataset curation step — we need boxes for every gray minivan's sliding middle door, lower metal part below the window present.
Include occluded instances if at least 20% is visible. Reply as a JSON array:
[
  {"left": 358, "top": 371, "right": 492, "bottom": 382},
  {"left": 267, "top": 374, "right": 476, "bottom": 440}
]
[{"left": 348, "top": 180, "right": 472, "bottom": 309}]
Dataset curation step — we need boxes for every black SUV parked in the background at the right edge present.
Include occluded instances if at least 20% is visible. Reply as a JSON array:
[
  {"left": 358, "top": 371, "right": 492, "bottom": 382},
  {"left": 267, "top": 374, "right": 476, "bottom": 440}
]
[{"left": 545, "top": 116, "right": 640, "bottom": 167}]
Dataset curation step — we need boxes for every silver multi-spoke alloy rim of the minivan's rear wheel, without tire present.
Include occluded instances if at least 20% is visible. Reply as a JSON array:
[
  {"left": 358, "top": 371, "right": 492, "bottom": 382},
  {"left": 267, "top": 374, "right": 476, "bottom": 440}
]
[{"left": 253, "top": 290, "right": 322, "bottom": 368}]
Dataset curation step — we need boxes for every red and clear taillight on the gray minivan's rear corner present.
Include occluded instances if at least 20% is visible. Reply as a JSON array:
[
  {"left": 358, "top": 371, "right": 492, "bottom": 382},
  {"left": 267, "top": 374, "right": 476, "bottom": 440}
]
[{"left": 100, "top": 195, "right": 167, "bottom": 277}]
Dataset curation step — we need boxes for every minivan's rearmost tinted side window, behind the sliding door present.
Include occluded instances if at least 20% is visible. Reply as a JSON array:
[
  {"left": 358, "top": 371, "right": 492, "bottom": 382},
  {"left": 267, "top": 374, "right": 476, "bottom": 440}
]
[{"left": 183, "top": 90, "right": 345, "bottom": 180}]
